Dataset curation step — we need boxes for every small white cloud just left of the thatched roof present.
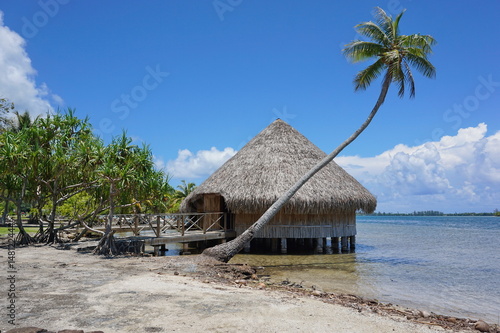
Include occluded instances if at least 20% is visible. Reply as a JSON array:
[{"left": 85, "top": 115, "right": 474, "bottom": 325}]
[{"left": 166, "top": 147, "right": 236, "bottom": 178}]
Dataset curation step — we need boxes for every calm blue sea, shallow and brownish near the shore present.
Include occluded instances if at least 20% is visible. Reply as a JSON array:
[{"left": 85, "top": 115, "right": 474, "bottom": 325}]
[{"left": 231, "top": 216, "right": 500, "bottom": 323}]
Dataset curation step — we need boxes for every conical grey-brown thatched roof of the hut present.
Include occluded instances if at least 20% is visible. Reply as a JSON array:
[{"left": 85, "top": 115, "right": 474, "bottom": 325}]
[{"left": 181, "top": 119, "right": 377, "bottom": 214}]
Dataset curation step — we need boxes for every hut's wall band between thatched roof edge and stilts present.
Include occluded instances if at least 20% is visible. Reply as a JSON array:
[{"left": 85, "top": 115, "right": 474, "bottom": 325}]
[{"left": 234, "top": 212, "right": 356, "bottom": 238}]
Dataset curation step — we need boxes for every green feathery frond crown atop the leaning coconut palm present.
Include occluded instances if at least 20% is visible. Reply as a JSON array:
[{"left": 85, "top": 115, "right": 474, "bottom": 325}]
[{"left": 342, "top": 7, "right": 436, "bottom": 98}]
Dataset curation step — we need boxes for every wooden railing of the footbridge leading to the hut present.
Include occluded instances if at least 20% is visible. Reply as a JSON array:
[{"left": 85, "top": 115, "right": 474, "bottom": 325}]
[{"left": 108, "top": 213, "right": 228, "bottom": 237}]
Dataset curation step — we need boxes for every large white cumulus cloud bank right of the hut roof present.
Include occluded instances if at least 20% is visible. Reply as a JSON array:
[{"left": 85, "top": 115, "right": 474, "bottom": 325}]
[{"left": 336, "top": 123, "right": 500, "bottom": 212}]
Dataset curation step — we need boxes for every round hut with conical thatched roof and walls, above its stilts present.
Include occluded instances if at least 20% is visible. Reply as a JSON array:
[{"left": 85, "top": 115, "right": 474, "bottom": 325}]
[{"left": 181, "top": 119, "right": 376, "bottom": 238}]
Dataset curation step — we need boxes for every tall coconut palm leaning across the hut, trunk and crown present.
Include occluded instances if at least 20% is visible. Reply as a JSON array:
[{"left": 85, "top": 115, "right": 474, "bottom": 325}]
[{"left": 203, "top": 7, "right": 436, "bottom": 262}]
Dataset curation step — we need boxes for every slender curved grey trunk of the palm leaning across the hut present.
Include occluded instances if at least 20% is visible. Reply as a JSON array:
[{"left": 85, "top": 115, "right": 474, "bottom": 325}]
[{"left": 203, "top": 73, "right": 392, "bottom": 262}]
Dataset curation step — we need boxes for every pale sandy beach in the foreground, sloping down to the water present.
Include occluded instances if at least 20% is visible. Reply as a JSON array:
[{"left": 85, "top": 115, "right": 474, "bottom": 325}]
[{"left": 0, "top": 246, "right": 492, "bottom": 333}]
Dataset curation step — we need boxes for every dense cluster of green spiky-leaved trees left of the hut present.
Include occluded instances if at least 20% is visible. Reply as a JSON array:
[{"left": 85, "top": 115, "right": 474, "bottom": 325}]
[{"left": 0, "top": 99, "right": 194, "bottom": 254}]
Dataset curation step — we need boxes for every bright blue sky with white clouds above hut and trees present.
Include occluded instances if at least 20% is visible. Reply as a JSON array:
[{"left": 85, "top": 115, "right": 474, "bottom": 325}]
[{"left": 0, "top": 0, "right": 500, "bottom": 212}]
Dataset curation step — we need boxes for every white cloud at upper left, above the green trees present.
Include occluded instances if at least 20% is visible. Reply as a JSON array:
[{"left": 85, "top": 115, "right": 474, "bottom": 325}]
[{"left": 0, "top": 11, "right": 63, "bottom": 116}]
